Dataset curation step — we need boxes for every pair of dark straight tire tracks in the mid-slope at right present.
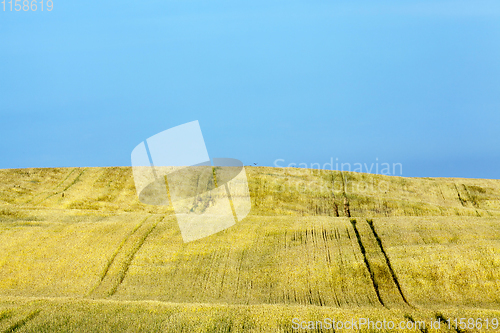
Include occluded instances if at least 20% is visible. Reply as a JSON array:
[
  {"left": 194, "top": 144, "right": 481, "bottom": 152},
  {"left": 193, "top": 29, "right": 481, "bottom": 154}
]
[{"left": 351, "top": 219, "right": 411, "bottom": 308}]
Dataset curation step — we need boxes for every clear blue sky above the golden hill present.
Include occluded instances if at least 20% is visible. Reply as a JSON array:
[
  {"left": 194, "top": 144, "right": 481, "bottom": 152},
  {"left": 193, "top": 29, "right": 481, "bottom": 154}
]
[{"left": 0, "top": 0, "right": 500, "bottom": 179}]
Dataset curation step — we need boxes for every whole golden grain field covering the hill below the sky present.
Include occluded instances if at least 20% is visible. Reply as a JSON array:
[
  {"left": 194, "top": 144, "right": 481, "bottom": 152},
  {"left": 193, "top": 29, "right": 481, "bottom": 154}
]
[{"left": 0, "top": 167, "right": 500, "bottom": 332}]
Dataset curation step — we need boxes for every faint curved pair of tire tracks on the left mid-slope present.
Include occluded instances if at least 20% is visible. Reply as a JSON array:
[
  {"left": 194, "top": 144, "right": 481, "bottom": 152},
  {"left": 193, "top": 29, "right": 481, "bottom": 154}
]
[{"left": 89, "top": 215, "right": 163, "bottom": 298}]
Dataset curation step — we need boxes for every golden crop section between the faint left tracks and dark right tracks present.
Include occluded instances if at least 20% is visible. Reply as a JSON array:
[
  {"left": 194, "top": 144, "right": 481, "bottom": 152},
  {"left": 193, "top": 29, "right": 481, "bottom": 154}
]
[{"left": 115, "top": 217, "right": 377, "bottom": 307}]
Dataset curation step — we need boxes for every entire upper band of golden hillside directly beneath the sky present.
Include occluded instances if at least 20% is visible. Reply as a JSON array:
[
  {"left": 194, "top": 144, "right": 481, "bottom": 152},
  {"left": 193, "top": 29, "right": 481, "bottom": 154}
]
[{"left": 0, "top": 167, "right": 500, "bottom": 217}]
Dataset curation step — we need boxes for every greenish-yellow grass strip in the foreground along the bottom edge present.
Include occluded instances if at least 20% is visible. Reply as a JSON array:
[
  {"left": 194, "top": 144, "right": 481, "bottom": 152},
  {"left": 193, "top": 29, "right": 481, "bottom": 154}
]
[{"left": 0, "top": 298, "right": 500, "bottom": 333}]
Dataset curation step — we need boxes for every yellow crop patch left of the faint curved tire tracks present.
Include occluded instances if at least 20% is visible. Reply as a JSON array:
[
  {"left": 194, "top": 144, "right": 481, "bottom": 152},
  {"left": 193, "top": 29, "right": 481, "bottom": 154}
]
[{"left": 0, "top": 211, "right": 154, "bottom": 296}]
